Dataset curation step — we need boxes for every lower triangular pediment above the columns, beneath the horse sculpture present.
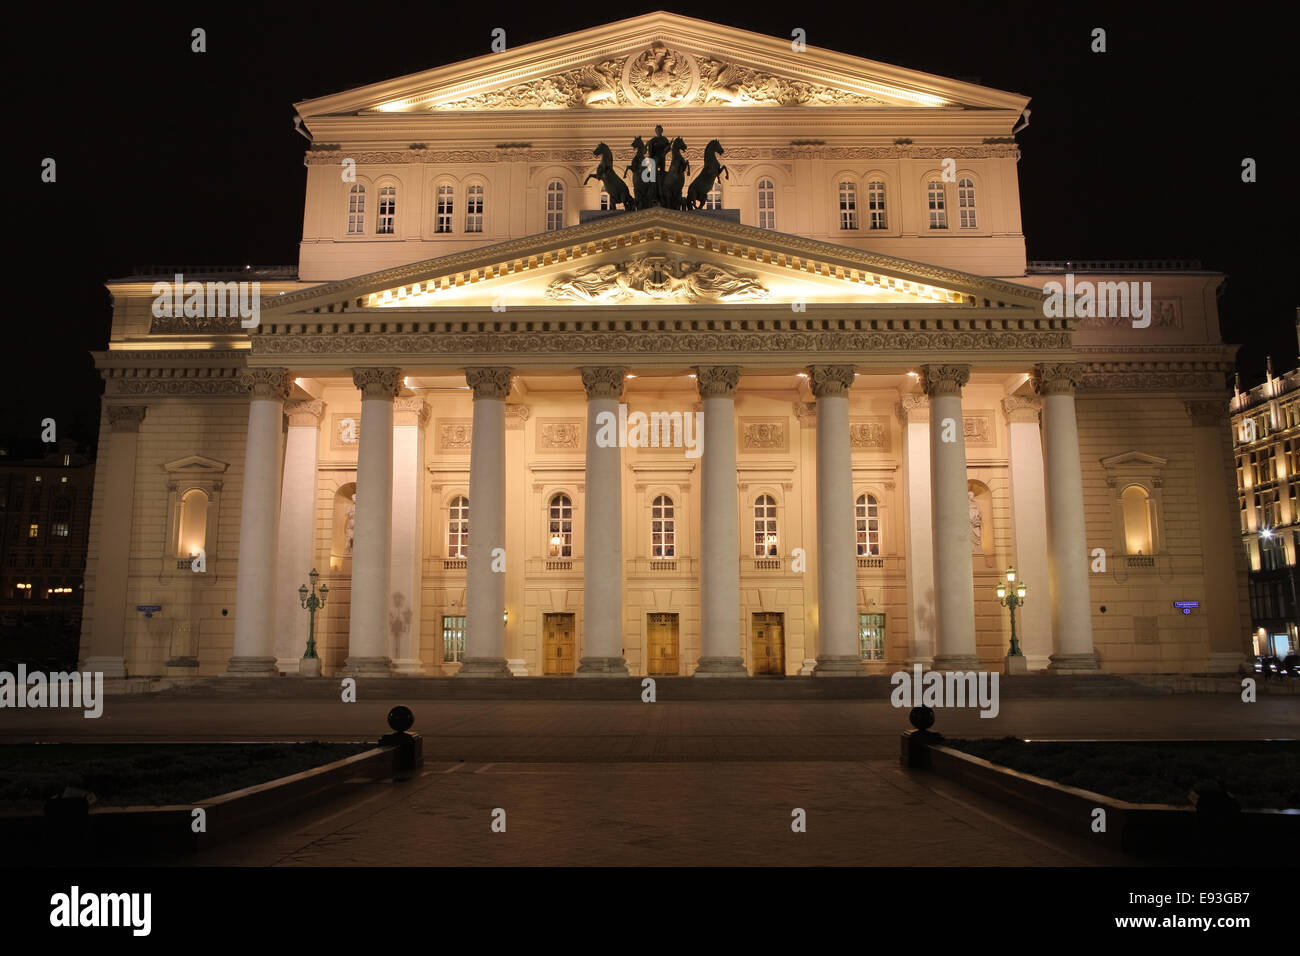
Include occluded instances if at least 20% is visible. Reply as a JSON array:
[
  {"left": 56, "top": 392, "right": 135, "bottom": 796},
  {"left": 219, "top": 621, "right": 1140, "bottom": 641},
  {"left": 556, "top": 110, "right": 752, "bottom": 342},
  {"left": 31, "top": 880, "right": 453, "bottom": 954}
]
[{"left": 261, "top": 208, "right": 1044, "bottom": 323}]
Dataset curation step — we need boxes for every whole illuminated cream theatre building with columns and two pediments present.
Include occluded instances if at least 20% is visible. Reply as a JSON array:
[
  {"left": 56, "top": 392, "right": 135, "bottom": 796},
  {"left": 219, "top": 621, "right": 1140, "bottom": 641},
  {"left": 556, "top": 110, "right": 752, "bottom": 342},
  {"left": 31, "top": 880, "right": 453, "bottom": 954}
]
[{"left": 82, "top": 13, "right": 1249, "bottom": 679}]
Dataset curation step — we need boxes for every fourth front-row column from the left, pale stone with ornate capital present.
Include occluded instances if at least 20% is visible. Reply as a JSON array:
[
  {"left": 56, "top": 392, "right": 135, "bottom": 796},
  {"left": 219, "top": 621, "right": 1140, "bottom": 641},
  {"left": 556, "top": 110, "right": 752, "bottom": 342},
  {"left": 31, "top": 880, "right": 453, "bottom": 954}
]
[{"left": 577, "top": 367, "right": 628, "bottom": 678}]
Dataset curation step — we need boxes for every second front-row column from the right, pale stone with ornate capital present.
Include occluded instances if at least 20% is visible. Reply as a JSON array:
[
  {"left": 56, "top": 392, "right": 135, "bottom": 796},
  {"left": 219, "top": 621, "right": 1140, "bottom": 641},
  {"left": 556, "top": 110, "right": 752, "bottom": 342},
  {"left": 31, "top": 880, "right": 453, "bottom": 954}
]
[{"left": 922, "top": 365, "right": 979, "bottom": 671}]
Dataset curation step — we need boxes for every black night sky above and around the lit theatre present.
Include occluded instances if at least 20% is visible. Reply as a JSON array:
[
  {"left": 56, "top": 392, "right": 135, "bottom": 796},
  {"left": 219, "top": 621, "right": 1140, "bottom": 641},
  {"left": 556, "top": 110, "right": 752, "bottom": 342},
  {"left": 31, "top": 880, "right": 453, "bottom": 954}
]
[{"left": 0, "top": 1, "right": 1300, "bottom": 453}]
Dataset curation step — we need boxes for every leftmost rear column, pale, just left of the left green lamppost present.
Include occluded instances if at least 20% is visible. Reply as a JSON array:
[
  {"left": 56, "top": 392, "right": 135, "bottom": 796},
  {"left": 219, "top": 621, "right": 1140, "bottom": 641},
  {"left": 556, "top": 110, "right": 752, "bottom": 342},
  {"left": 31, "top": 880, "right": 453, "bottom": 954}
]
[{"left": 276, "top": 399, "right": 323, "bottom": 674}]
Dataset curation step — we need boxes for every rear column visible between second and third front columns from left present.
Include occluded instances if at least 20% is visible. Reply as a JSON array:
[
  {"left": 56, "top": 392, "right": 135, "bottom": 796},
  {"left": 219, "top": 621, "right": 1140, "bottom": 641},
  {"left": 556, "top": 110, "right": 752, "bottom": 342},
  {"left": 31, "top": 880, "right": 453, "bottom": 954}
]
[{"left": 387, "top": 398, "right": 429, "bottom": 674}]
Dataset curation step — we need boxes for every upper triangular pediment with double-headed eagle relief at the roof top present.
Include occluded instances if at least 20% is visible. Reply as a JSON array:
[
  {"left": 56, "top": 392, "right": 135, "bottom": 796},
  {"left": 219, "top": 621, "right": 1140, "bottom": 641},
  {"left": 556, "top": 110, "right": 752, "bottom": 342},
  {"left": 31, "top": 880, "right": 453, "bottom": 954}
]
[{"left": 296, "top": 12, "right": 1028, "bottom": 120}]
